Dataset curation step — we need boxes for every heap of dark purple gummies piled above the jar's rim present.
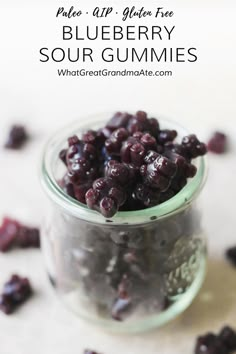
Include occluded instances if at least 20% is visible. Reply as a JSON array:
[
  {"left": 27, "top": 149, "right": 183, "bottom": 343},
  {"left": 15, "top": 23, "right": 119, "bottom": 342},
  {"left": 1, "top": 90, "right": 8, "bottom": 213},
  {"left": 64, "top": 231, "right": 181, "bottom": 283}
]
[{"left": 59, "top": 111, "right": 206, "bottom": 218}]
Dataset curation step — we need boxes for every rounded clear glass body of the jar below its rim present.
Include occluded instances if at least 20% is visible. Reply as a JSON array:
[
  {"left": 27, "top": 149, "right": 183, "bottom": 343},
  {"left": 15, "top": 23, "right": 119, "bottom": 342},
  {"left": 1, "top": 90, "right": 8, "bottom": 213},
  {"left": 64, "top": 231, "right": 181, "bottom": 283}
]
[{"left": 43, "top": 203, "right": 206, "bottom": 330}]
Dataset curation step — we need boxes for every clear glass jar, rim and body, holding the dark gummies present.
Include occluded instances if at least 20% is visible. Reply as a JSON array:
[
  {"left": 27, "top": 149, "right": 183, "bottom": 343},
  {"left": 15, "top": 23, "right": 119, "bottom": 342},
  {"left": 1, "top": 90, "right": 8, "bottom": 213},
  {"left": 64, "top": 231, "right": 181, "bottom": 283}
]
[{"left": 41, "top": 114, "right": 206, "bottom": 332}]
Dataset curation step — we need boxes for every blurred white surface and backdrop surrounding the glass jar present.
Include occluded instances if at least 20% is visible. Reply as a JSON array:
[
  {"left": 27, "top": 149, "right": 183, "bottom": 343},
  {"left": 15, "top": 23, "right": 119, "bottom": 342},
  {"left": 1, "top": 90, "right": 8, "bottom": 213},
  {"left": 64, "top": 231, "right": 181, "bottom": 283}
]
[{"left": 0, "top": 0, "right": 236, "bottom": 354}]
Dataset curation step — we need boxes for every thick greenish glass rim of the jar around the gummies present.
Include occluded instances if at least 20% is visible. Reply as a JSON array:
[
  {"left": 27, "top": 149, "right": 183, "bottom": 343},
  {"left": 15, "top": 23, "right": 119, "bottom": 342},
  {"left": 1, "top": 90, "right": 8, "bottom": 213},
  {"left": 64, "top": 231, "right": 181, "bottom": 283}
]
[{"left": 41, "top": 112, "right": 206, "bottom": 225}]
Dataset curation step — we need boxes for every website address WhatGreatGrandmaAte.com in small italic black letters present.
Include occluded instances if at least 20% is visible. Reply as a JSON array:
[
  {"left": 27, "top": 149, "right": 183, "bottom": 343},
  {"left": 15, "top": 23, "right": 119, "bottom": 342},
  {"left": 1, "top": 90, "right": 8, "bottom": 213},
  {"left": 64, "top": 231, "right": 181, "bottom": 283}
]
[{"left": 57, "top": 69, "right": 173, "bottom": 77}]
